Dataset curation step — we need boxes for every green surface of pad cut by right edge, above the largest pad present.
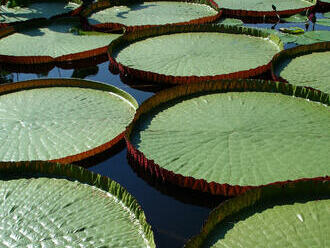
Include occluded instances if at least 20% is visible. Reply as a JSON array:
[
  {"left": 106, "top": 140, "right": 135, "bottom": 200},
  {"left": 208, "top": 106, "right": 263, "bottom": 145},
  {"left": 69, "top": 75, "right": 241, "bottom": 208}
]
[{"left": 275, "top": 51, "right": 330, "bottom": 94}]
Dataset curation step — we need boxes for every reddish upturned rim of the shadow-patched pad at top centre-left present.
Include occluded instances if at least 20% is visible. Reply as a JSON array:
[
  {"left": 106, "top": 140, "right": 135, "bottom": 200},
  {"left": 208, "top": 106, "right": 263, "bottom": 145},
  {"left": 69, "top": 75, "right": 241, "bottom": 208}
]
[{"left": 81, "top": 0, "right": 222, "bottom": 32}]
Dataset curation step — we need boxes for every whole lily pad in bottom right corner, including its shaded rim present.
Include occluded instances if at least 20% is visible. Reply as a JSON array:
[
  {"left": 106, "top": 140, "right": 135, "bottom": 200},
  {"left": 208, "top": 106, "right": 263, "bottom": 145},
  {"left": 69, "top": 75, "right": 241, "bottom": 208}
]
[{"left": 185, "top": 178, "right": 330, "bottom": 248}]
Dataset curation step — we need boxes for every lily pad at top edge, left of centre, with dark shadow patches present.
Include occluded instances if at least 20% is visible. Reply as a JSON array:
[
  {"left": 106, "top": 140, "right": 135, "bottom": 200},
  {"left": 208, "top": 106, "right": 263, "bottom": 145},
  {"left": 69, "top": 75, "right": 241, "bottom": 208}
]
[{"left": 84, "top": 1, "right": 220, "bottom": 29}]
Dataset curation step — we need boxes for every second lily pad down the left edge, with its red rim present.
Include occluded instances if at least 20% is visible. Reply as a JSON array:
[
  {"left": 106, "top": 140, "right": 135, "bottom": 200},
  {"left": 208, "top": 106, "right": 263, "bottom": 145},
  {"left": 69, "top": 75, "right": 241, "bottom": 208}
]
[{"left": 0, "top": 18, "right": 120, "bottom": 64}]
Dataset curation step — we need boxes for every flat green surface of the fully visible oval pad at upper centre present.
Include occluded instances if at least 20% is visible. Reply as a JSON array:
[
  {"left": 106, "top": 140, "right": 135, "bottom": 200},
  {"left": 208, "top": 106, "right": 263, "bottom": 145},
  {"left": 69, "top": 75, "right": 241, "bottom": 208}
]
[{"left": 114, "top": 29, "right": 280, "bottom": 76}]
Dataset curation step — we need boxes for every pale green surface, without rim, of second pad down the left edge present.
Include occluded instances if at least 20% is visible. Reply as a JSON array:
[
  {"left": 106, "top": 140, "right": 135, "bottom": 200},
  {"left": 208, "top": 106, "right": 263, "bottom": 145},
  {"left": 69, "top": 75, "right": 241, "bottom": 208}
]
[{"left": 0, "top": 19, "right": 120, "bottom": 58}]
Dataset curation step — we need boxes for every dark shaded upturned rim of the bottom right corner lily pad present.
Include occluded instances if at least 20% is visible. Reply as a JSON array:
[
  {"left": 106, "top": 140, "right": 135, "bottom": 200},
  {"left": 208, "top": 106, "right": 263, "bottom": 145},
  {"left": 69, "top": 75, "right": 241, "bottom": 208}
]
[{"left": 184, "top": 177, "right": 330, "bottom": 248}]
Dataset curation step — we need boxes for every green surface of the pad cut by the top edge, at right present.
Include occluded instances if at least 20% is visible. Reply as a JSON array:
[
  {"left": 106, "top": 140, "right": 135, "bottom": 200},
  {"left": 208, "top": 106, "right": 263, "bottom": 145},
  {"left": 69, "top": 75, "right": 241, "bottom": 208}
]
[{"left": 215, "top": 0, "right": 315, "bottom": 11}]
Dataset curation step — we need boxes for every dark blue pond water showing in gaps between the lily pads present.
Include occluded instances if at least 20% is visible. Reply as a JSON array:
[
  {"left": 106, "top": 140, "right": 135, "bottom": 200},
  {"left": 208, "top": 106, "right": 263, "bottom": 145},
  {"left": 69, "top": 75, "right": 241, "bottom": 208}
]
[{"left": 0, "top": 13, "right": 330, "bottom": 248}]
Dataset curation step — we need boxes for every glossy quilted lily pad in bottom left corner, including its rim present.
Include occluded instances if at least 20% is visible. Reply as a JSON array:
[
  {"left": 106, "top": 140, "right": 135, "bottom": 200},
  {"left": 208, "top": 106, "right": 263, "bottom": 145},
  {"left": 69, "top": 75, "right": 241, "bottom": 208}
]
[{"left": 0, "top": 162, "right": 155, "bottom": 247}]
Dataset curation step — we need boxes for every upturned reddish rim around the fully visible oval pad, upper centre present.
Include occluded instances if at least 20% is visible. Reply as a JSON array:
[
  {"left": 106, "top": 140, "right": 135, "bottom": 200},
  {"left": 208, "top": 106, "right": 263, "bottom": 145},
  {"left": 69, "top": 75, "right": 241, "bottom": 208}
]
[{"left": 108, "top": 24, "right": 283, "bottom": 84}]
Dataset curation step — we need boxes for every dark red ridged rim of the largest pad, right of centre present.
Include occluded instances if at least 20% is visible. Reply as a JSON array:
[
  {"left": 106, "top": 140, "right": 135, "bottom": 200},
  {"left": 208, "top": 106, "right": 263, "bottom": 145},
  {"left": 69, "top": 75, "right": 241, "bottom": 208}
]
[{"left": 125, "top": 79, "right": 330, "bottom": 196}]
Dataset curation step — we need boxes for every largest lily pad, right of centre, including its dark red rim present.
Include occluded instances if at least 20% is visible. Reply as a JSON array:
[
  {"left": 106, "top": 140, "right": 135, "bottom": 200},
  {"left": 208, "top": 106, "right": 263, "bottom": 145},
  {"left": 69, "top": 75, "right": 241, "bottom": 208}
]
[{"left": 127, "top": 80, "right": 330, "bottom": 195}]
